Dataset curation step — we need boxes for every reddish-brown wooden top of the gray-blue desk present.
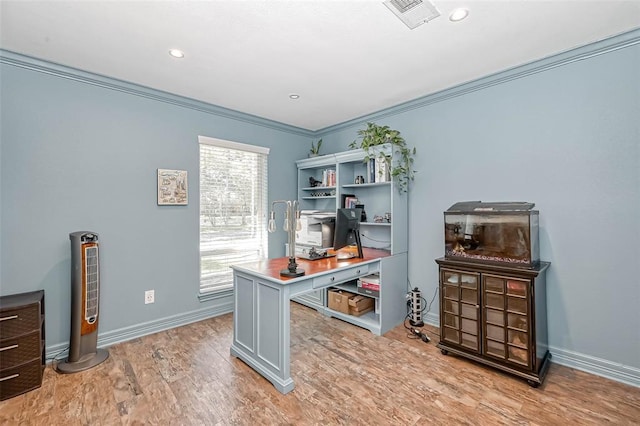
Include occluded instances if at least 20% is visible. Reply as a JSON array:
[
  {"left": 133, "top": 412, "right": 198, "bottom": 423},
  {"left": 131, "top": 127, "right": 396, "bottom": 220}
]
[{"left": 231, "top": 248, "right": 391, "bottom": 282}]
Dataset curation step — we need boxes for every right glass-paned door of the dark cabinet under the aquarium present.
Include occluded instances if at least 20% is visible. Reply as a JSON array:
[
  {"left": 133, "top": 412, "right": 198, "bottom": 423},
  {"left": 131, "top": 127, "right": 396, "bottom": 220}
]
[{"left": 482, "top": 274, "right": 531, "bottom": 367}]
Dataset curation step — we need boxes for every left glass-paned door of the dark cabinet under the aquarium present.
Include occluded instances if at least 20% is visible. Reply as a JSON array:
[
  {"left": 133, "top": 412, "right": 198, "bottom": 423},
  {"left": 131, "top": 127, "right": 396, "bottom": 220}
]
[{"left": 440, "top": 269, "right": 480, "bottom": 352}]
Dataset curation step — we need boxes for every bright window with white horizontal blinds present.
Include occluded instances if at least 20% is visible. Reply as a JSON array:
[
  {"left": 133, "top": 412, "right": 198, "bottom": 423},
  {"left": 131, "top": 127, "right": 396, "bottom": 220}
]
[{"left": 198, "top": 136, "right": 269, "bottom": 298}]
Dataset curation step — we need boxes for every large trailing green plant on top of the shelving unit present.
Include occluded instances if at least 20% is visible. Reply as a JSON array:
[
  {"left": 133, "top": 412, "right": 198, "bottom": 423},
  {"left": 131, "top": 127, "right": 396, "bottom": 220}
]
[{"left": 349, "top": 122, "right": 416, "bottom": 192}]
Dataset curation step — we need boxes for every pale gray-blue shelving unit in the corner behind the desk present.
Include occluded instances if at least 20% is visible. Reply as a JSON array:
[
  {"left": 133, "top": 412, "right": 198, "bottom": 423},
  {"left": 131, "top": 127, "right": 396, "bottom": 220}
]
[{"left": 293, "top": 145, "right": 408, "bottom": 334}]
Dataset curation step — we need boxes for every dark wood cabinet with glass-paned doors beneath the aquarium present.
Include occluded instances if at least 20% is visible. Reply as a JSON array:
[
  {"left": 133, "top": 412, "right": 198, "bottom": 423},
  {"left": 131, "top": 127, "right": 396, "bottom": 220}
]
[{"left": 436, "top": 258, "right": 551, "bottom": 386}]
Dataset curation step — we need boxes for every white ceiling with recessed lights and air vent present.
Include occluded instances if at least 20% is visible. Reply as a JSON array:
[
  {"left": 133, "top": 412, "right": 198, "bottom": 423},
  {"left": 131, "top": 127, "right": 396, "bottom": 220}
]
[{"left": 0, "top": 0, "right": 640, "bottom": 130}]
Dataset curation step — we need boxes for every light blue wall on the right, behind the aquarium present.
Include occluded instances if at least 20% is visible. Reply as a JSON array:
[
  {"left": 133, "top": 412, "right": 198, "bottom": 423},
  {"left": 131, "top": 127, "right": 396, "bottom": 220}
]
[{"left": 322, "top": 31, "right": 640, "bottom": 386}]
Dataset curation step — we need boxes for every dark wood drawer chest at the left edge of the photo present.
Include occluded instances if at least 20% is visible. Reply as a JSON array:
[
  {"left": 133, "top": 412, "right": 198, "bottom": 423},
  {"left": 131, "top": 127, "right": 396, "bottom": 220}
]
[{"left": 0, "top": 290, "right": 45, "bottom": 401}]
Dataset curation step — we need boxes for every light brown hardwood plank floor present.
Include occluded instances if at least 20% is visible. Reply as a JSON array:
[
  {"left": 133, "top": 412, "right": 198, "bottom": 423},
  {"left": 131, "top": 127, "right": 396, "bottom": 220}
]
[{"left": 0, "top": 302, "right": 640, "bottom": 425}]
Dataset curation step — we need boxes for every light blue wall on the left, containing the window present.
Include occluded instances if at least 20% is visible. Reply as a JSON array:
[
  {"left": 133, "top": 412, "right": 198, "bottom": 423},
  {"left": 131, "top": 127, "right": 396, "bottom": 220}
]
[{"left": 0, "top": 52, "right": 310, "bottom": 352}]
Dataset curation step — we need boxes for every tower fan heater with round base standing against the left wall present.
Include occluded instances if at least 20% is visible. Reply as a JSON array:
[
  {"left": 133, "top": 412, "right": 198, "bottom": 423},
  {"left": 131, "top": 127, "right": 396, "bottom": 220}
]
[{"left": 56, "top": 231, "right": 109, "bottom": 373}]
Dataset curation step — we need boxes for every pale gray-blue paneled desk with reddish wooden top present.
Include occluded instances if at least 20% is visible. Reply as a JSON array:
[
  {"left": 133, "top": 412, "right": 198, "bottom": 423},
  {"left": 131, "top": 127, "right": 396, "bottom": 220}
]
[{"left": 231, "top": 249, "right": 407, "bottom": 393}]
